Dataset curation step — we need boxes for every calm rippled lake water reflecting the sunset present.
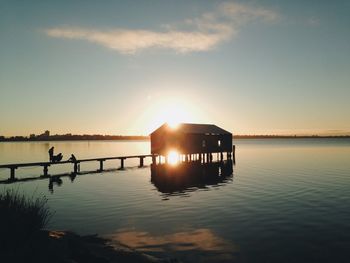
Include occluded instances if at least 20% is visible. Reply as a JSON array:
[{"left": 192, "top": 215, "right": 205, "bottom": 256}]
[{"left": 0, "top": 139, "right": 350, "bottom": 262}]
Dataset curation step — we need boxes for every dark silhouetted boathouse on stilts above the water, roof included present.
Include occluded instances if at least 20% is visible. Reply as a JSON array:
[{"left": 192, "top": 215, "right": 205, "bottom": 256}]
[{"left": 151, "top": 123, "right": 234, "bottom": 163}]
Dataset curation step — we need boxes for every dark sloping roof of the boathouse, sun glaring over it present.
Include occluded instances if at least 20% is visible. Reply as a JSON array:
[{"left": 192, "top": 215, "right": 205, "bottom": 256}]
[{"left": 151, "top": 123, "right": 231, "bottom": 135}]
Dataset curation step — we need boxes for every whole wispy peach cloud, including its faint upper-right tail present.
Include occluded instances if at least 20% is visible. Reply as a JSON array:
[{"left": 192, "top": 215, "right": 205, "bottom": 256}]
[{"left": 45, "top": 2, "right": 278, "bottom": 54}]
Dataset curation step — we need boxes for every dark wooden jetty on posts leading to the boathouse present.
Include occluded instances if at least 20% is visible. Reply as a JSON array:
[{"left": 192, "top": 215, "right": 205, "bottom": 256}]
[{"left": 0, "top": 154, "right": 157, "bottom": 181}]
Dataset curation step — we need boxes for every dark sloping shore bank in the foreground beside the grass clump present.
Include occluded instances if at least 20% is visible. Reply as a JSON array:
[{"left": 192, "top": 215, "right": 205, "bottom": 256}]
[{"left": 5, "top": 230, "right": 179, "bottom": 263}]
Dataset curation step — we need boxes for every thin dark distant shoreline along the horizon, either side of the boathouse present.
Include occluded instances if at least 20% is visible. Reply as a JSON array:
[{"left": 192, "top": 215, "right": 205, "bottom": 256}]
[{"left": 0, "top": 135, "right": 350, "bottom": 142}]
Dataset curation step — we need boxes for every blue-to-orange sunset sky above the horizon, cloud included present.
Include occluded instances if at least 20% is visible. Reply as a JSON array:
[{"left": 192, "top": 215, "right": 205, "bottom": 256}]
[{"left": 0, "top": 0, "right": 350, "bottom": 136}]
